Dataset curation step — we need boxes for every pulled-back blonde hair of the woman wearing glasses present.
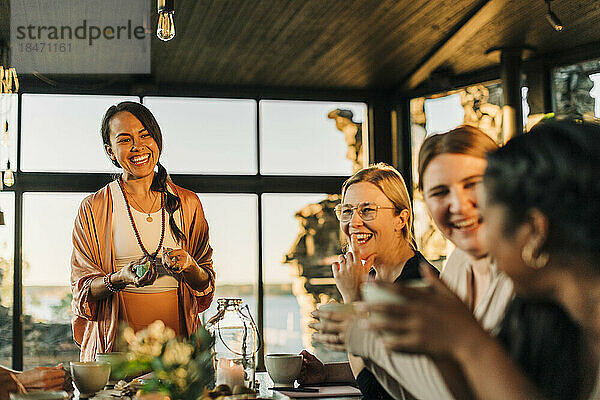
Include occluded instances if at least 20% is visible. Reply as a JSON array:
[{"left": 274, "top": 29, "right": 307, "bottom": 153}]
[{"left": 342, "top": 163, "right": 417, "bottom": 250}]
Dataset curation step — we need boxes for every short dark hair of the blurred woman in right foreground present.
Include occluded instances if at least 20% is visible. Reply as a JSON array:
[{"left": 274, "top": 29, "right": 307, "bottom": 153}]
[{"left": 484, "top": 120, "right": 600, "bottom": 257}]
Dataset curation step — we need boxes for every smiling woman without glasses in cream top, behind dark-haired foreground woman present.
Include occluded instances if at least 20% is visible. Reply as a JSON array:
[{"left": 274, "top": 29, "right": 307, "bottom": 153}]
[{"left": 312, "top": 126, "right": 513, "bottom": 400}]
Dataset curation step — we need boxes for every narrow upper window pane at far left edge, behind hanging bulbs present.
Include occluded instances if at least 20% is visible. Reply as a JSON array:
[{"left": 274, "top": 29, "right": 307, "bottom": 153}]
[{"left": 0, "top": 94, "right": 19, "bottom": 170}]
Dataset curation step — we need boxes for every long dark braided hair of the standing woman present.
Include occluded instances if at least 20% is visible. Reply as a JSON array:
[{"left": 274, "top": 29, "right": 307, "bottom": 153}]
[{"left": 101, "top": 101, "right": 187, "bottom": 244}]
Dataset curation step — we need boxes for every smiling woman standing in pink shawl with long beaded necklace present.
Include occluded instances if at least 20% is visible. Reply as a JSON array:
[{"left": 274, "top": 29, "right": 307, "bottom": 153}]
[{"left": 71, "top": 102, "right": 215, "bottom": 361}]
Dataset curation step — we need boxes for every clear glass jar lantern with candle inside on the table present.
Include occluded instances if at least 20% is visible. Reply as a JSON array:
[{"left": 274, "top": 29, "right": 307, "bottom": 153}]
[{"left": 206, "top": 298, "right": 258, "bottom": 389}]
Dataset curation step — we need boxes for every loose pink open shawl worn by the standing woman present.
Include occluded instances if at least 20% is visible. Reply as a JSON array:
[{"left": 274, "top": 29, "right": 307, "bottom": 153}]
[{"left": 71, "top": 182, "right": 215, "bottom": 361}]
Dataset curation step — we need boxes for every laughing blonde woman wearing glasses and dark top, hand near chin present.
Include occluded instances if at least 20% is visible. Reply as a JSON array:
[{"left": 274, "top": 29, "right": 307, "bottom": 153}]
[{"left": 300, "top": 163, "right": 437, "bottom": 399}]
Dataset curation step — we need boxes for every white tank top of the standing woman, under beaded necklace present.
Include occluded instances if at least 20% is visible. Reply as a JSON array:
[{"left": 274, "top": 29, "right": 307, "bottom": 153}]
[{"left": 109, "top": 181, "right": 181, "bottom": 293}]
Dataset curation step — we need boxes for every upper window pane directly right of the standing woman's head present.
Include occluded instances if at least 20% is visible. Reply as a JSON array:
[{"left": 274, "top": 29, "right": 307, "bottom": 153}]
[{"left": 143, "top": 97, "right": 256, "bottom": 174}]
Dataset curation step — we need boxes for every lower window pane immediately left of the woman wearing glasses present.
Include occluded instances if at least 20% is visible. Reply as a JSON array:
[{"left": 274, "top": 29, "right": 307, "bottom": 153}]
[{"left": 263, "top": 194, "right": 346, "bottom": 361}]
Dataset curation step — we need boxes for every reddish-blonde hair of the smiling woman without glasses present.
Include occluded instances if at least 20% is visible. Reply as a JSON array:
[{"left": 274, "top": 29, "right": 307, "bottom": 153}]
[{"left": 418, "top": 125, "right": 498, "bottom": 190}]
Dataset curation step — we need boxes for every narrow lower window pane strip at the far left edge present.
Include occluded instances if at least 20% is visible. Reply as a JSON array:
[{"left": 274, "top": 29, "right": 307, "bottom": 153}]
[{"left": 0, "top": 192, "right": 15, "bottom": 366}]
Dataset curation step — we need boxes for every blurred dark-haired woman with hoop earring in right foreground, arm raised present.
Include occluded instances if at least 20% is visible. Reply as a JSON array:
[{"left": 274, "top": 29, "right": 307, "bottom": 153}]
[{"left": 366, "top": 122, "right": 600, "bottom": 399}]
